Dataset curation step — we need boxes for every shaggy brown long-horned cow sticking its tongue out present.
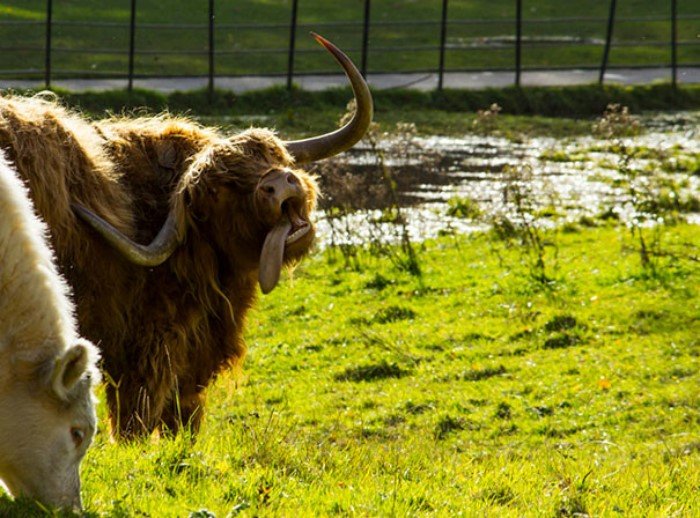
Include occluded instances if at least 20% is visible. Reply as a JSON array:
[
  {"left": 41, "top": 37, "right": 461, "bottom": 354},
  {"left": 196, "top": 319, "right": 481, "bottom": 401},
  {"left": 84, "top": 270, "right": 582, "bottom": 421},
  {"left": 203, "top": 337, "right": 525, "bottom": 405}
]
[{"left": 0, "top": 36, "right": 372, "bottom": 437}]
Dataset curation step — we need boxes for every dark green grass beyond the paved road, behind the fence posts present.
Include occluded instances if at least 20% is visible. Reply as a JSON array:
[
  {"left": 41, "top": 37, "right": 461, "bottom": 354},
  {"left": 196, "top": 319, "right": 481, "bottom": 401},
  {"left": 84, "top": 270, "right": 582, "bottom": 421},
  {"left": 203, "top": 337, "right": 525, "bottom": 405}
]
[{"left": 0, "top": 0, "right": 700, "bottom": 77}]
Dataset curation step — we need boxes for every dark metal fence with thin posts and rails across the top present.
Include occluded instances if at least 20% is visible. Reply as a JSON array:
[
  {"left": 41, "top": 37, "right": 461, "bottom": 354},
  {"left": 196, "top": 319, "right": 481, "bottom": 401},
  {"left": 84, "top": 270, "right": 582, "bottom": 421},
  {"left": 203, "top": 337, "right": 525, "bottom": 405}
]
[{"left": 0, "top": 0, "right": 700, "bottom": 91}]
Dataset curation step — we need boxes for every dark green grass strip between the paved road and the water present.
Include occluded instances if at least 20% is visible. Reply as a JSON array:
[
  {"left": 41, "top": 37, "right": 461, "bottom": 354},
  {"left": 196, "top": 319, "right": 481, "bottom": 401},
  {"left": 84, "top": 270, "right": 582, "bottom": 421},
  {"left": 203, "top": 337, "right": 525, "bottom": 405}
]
[{"left": 35, "top": 84, "right": 700, "bottom": 138}]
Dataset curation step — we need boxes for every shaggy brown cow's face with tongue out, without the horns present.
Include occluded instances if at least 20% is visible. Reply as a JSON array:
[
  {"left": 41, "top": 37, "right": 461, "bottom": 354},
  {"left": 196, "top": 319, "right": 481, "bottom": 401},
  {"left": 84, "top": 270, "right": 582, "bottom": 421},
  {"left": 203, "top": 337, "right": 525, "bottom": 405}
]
[{"left": 173, "top": 129, "right": 318, "bottom": 293}]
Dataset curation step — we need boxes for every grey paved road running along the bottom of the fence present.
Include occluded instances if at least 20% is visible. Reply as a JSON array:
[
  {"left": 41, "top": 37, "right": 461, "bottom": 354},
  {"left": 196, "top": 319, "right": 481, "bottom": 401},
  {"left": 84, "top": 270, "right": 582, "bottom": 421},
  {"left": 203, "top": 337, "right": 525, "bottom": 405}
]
[{"left": 0, "top": 67, "right": 700, "bottom": 92}]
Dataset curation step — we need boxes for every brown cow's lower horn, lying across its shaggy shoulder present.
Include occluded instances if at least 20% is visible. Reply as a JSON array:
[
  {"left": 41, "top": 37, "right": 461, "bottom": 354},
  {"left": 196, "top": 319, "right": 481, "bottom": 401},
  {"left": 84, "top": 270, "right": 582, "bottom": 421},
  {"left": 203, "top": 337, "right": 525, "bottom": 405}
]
[{"left": 72, "top": 203, "right": 181, "bottom": 266}]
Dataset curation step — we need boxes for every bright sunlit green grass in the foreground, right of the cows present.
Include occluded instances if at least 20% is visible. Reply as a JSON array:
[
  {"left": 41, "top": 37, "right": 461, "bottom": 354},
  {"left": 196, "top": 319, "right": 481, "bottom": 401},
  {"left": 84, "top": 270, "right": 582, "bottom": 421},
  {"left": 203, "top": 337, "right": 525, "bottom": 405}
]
[{"left": 0, "top": 225, "right": 700, "bottom": 517}]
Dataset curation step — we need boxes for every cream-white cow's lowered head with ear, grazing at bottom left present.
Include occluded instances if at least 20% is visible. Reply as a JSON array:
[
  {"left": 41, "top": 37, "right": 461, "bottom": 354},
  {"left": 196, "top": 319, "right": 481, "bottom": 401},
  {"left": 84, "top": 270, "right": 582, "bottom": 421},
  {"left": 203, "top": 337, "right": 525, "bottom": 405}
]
[{"left": 0, "top": 340, "right": 97, "bottom": 508}]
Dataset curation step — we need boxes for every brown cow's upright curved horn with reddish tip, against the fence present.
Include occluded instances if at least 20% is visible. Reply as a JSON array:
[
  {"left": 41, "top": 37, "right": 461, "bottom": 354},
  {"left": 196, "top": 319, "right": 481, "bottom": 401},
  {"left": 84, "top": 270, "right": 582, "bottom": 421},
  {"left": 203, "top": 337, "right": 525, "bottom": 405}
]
[{"left": 285, "top": 32, "right": 374, "bottom": 163}]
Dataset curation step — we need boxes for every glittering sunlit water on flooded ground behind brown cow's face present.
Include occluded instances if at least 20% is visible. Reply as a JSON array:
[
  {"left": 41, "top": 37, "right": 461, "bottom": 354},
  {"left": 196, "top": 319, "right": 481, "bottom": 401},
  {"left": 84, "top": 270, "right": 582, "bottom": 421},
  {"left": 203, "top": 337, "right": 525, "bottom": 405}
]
[{"left": 317, "top": 113, "right": 700, "bottom": 246}]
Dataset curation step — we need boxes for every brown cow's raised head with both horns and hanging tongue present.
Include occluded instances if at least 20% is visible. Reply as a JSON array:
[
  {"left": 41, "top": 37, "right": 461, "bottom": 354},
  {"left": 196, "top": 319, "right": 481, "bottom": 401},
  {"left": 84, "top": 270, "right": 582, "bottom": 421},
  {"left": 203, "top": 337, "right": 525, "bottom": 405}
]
[{"left": 74, "top": 35, "right": 373, "bottom": 293}]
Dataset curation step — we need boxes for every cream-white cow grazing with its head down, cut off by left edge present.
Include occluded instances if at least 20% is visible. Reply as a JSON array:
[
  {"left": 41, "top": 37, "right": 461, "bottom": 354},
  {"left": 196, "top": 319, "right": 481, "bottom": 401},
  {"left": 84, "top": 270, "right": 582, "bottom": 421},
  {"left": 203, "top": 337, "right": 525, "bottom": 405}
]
[{"left": 0, "top": 153, "right": 98, "bottom": 508}]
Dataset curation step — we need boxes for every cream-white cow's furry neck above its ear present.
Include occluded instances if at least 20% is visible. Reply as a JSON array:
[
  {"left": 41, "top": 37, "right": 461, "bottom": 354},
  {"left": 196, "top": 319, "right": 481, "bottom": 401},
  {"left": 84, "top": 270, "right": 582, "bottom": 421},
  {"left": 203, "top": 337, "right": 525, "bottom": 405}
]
[{"left": 0, "top": 153, "right": 97, "bottom": 376}]
